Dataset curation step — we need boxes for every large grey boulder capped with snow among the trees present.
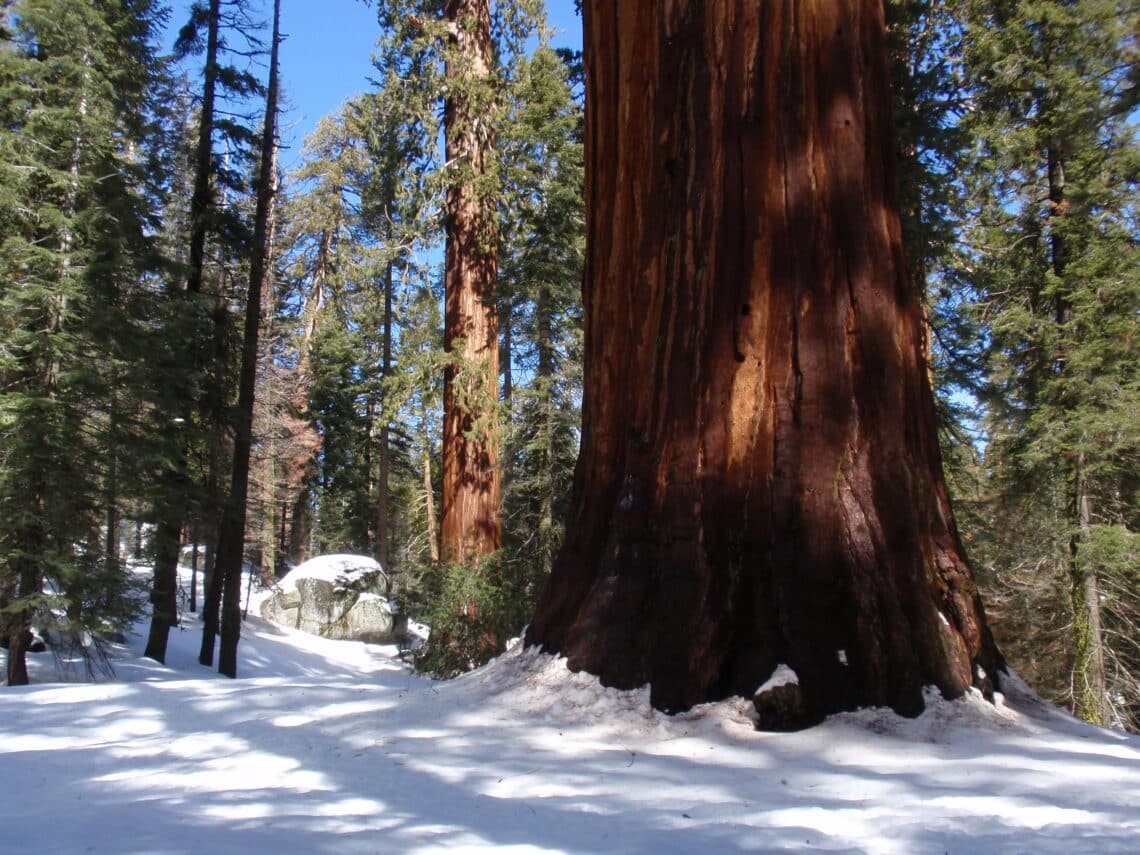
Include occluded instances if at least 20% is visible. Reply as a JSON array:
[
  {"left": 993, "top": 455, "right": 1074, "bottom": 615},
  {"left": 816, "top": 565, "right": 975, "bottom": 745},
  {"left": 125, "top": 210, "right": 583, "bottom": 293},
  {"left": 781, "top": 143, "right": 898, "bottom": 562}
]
[{"left": 261, "top": 555, "right": 407, "bottom": 643}]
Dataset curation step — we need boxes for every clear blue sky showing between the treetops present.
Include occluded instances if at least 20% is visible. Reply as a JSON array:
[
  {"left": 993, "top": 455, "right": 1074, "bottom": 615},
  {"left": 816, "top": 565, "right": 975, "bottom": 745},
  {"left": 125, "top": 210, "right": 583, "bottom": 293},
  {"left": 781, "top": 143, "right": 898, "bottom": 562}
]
[{"left": 170, "top": 0, "right": 581, "bottom": 169}]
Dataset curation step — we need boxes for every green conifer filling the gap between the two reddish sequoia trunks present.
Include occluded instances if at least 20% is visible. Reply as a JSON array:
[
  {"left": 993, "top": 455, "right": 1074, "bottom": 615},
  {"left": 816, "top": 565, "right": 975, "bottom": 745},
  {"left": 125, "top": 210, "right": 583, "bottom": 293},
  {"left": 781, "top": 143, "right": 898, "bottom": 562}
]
[{"left": 499, "top": 44, "right": 585, "bottom": 633}]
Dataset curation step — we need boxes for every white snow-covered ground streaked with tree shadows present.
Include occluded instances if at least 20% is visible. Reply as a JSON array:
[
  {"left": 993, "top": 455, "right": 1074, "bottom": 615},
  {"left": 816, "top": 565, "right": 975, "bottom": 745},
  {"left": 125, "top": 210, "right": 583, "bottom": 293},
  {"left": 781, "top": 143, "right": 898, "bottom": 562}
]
[{"left": 0, "top": 565, "right": 1140, "bottom": 855}]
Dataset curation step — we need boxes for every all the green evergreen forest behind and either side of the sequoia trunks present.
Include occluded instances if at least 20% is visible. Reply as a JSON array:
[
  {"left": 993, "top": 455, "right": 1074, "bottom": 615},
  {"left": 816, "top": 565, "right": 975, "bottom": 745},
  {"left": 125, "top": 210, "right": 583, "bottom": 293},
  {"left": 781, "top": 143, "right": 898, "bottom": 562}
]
[{"left": 0, "top": 0, "right": 1140, "bottom": 730}]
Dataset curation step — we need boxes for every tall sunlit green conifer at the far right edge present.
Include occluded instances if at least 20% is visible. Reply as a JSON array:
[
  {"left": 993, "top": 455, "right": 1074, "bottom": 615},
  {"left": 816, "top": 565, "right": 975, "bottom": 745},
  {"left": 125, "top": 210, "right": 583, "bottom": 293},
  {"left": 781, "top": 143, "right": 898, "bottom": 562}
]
[{"left": 967, "top": 0, "right": 1140, "bottom": 727}]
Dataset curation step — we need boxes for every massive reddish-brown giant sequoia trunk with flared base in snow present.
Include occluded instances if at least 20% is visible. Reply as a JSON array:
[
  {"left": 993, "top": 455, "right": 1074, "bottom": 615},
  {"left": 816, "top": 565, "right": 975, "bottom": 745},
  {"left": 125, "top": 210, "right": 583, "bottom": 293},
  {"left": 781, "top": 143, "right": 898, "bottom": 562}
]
[{"left": 528, "top": 0, "right": 1002, "bottom": 724}]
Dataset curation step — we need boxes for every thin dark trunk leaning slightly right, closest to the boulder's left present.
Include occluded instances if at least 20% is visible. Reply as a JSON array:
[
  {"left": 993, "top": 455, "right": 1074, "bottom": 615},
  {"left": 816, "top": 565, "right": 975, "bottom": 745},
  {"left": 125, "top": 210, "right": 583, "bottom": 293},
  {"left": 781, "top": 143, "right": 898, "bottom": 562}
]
[{"left": 215, "top": 0, "right": 280, "bottom": 677}]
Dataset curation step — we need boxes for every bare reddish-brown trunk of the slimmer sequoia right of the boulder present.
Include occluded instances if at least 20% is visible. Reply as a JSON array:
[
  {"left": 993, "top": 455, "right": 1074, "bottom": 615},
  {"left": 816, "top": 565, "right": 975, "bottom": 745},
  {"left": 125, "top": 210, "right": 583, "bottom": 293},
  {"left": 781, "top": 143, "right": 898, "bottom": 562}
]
[{"left": 440, "top": 0, "right": 502, "bottom": 564}]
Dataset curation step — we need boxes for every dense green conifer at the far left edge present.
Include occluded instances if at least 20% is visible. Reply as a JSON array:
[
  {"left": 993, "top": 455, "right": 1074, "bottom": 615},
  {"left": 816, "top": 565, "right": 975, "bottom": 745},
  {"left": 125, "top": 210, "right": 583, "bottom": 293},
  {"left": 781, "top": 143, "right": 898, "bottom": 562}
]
[{"left": 0, "top": 0, "right": 165, "bottom": 684}]
